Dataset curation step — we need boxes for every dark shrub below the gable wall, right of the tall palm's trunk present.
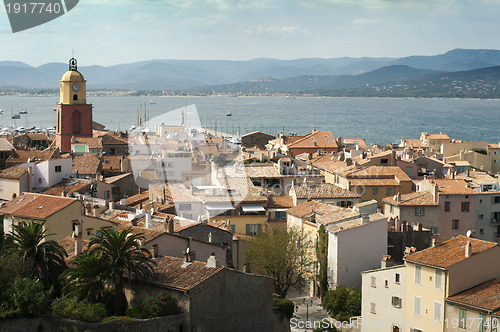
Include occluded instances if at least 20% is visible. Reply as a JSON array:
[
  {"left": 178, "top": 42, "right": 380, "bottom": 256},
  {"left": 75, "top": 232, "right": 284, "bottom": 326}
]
[{"left": 127, "top": 292, "right": 181, "bottom": 319}]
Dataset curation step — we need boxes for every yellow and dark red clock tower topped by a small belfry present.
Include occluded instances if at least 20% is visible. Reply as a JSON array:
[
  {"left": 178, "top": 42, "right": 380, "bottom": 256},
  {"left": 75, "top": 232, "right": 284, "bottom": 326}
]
[{"left": 56, "top": 58, "right": 92, "bottom": 152}]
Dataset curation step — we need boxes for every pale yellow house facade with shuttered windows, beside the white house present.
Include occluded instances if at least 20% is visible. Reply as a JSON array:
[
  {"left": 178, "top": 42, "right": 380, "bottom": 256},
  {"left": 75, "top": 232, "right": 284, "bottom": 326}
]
[{"left": 404, "top": 262, "right": 448, "bottom": 332}]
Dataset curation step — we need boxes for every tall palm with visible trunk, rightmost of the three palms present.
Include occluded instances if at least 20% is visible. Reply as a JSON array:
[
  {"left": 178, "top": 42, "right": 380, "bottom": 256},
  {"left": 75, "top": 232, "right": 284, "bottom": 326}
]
[{"left": 89, "top": 227, "right": 156, "bottom": 316}]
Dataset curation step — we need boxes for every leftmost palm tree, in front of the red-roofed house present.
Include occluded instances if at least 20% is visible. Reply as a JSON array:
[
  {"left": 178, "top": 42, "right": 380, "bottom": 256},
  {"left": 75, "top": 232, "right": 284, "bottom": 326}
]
[{"left": 8, "top": 220, "right": 68, "bottom": 285}]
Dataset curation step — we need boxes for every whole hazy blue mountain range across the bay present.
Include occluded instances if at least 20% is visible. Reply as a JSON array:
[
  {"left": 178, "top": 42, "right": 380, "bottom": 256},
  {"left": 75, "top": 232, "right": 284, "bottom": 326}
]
[{"left": 0, "top": 49, "right": 500, "bottom": 98}]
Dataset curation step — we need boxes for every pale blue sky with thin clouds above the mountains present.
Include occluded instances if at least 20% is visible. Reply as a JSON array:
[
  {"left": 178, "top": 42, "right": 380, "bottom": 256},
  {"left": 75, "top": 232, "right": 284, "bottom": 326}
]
[{"left": 0, "top": 0, "right": 500, "bottom": 66}]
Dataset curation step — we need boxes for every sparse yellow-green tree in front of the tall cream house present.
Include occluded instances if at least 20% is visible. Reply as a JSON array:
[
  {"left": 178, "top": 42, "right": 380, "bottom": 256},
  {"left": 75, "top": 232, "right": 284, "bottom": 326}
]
[{"left": 246, "top": 228, "right": 310, "bottom": 299}]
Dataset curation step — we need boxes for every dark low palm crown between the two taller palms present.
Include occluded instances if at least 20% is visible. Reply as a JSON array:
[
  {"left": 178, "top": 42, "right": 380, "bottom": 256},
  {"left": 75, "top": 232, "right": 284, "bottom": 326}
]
[{"left": 62, "top": 252, "right": 110, "bottom": 303}]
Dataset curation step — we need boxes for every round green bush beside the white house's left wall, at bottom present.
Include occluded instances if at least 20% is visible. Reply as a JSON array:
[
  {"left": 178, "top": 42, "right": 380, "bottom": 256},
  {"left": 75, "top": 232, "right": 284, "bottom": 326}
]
[{"left": 322, "top": 286, "right": 361, "bottom": 321}]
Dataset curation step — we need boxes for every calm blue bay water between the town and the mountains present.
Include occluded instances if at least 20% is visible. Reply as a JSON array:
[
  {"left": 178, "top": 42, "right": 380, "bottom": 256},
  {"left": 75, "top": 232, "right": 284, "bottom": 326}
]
[{"left": 0, "top": 96, "right": 500, "bottom": 144}]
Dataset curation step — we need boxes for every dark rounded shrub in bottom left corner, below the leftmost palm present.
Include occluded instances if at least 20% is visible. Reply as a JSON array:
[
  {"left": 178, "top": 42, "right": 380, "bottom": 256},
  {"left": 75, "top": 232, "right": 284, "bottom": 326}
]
[{"left": 9, "top": 278, "right": 50, "bottom": 317}]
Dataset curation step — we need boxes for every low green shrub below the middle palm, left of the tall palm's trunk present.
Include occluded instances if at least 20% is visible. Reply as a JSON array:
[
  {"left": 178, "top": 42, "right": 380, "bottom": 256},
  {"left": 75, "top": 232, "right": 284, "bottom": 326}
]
[{"left": 52, "top": 297, "right": 107, "bottom": 322}]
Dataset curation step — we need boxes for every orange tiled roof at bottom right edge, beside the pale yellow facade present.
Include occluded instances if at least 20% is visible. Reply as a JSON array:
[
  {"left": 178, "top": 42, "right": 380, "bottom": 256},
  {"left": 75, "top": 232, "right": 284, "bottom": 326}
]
[{"left": 447, "top": 279, "right": 500, "bottom": 311}]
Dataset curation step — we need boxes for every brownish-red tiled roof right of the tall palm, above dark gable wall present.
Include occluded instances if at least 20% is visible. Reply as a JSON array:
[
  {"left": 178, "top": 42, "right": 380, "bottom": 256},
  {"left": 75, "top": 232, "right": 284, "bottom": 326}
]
[{"left": 149, "top": 256, "right": 224, "bottom": 290}]
